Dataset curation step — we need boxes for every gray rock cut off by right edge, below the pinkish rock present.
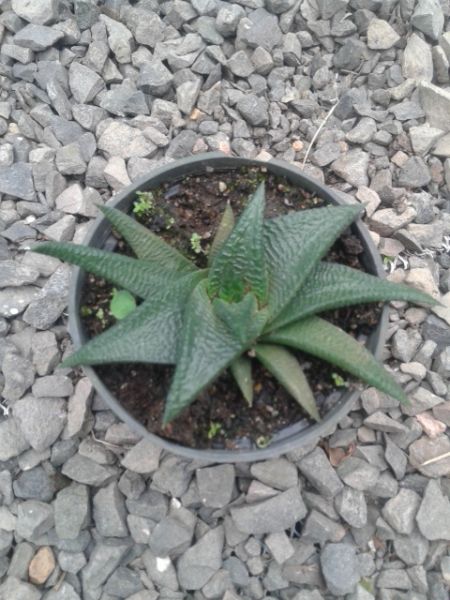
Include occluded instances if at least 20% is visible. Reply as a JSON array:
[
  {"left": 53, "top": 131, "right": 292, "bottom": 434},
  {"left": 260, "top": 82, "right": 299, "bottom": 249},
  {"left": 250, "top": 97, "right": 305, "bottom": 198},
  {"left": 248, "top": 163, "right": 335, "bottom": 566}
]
[{"left": 416, "top": 479, "right": 450, "bottom": 541}]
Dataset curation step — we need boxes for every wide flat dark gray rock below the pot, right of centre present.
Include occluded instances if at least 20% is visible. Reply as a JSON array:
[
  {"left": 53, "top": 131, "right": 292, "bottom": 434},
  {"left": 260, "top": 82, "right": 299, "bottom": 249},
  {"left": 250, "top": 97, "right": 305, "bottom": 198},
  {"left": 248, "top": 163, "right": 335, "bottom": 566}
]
[{"left": 231, "top": 487, "right": 306, "bottom": 535}]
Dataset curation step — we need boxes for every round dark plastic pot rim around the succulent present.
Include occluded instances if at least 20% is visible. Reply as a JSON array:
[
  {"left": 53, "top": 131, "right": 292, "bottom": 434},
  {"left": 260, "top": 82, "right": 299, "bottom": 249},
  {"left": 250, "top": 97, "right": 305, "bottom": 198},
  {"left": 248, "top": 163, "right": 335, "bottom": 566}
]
[{"left": 69, "top": 153, "right": 388, "bottom": 462}]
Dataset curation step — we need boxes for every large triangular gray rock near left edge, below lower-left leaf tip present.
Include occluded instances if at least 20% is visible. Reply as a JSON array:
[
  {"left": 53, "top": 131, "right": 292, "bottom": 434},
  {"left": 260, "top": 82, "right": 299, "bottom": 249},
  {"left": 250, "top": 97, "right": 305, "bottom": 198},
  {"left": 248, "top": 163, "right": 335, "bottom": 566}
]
[{"left": 13, "top": 396, "right": 67, "bottom": 452}]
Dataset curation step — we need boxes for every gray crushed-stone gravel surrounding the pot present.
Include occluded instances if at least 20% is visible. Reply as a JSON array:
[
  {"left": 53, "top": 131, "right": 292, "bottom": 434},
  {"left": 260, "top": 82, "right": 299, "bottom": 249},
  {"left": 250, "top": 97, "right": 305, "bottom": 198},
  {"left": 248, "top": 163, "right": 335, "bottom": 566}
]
[{"left": 0, "top": 0, "right": 450, "bottom": 600}]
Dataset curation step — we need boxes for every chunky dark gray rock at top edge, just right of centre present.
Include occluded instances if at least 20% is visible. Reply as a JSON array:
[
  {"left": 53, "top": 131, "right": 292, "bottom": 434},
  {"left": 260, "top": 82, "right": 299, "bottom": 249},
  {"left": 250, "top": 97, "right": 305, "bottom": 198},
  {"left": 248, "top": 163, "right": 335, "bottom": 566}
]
[{"left": 237, "top": 8, "right": 283, "bottom": 51}]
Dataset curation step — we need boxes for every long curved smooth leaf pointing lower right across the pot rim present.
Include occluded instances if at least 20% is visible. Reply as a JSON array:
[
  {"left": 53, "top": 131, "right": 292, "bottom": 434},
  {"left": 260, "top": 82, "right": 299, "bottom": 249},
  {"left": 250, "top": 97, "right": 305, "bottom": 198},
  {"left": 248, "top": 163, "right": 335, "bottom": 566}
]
[{"left": 263, "top": 317, "right": 409, "bottom": 404}]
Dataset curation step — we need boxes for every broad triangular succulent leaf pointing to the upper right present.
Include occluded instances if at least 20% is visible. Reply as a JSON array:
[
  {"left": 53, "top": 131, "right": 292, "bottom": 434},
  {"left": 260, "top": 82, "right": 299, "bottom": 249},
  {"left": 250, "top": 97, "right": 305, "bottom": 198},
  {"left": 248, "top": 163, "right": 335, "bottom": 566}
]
[{"left": 264, "top": 205, "right": 361, "bottom": 320}]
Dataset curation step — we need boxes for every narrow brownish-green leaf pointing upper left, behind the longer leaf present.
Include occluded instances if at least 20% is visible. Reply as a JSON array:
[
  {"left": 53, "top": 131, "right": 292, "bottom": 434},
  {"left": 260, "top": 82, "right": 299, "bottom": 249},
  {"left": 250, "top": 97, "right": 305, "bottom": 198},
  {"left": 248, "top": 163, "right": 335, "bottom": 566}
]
[{"left": 99, "top": 206, "right": 196, "bottom": 272}]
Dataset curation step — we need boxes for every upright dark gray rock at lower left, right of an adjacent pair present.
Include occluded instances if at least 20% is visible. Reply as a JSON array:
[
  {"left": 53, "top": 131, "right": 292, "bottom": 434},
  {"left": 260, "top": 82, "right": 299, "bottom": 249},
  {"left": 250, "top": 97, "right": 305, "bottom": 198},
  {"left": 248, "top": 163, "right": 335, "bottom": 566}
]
[{"left": 93, "top": 481, "right": 128, "bottom": 537}]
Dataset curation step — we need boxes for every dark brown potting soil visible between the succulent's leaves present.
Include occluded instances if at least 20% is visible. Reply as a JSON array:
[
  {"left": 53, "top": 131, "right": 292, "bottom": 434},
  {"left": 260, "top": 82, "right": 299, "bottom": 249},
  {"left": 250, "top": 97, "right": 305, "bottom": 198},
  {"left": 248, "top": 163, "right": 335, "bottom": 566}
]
[{"left": 81, "top": 167, "right": 381, "bottom": 449}]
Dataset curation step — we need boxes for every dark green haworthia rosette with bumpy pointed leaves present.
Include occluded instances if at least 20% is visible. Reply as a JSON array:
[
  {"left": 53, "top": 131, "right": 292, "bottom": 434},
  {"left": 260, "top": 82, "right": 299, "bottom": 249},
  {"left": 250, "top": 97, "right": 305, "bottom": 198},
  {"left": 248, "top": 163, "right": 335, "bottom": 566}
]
[{"left": 35, "top": 184, "right": 437, "bottom": 424}]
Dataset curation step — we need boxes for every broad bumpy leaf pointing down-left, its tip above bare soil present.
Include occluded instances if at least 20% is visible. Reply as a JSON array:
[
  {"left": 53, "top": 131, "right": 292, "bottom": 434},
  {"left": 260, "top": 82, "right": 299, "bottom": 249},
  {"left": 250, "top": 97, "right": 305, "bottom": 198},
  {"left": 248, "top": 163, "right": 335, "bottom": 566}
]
[{"left": 163, "top": 281, "right": 250, "bottom": 424}]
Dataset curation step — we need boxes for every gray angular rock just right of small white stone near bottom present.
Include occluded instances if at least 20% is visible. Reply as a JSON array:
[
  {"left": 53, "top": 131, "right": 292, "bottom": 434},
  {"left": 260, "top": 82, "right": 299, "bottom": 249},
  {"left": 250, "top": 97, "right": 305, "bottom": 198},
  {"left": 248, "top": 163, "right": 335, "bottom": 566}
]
[{"left": 177, "top": 526, "right": 224, "bottom": 590}]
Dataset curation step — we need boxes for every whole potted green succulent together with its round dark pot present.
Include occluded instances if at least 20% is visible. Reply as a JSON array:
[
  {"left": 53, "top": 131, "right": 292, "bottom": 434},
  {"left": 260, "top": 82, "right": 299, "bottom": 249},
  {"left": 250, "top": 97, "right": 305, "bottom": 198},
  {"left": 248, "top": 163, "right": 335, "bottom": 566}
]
[{"left": 35, "top": 154, "right": 435, "bottom": 461}]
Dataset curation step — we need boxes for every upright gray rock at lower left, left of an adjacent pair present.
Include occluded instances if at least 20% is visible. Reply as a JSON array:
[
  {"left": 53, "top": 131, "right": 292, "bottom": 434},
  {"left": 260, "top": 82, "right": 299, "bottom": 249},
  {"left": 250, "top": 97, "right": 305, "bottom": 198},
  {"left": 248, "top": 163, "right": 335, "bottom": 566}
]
[{"left": 54, "top": 483, "right": 90, "bottom": 540}]
